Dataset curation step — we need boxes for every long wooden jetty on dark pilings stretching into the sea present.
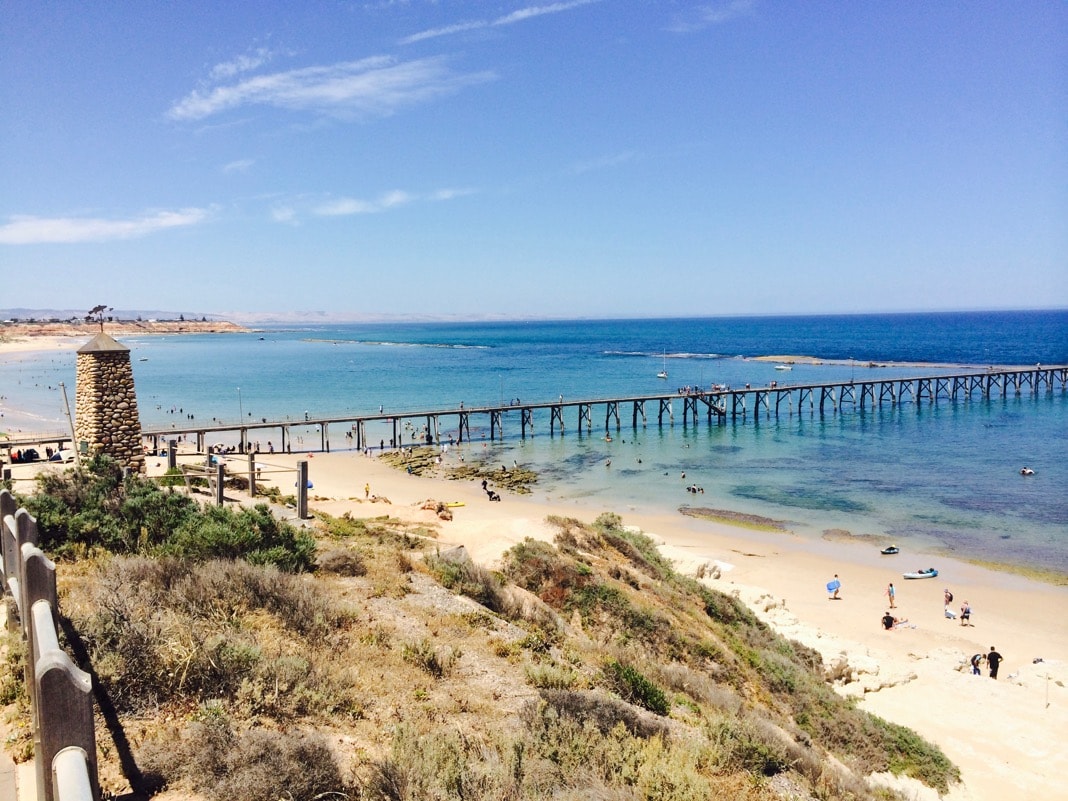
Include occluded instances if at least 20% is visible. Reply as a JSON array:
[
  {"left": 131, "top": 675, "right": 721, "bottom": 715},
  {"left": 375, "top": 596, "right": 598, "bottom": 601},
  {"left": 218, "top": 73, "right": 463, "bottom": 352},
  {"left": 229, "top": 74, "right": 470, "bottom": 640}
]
[{"left": 3, "top": 365, "right": 1068, "bottom": 453}]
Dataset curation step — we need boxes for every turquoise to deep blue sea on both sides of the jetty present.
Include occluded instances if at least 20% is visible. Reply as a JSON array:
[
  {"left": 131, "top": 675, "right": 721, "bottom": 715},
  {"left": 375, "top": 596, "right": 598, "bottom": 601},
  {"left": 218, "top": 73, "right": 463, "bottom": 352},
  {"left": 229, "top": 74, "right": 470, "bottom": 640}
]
[{"left": 0, "top": 311, "right": 1068, "bottom": 572}]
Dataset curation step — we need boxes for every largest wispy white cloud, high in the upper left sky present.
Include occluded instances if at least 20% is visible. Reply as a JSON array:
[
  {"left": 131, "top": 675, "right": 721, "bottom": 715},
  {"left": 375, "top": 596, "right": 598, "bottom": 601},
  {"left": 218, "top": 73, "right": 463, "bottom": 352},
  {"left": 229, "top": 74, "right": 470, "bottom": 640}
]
[{"left": 168, "top": 56, "right": 494, "bottom": 121}]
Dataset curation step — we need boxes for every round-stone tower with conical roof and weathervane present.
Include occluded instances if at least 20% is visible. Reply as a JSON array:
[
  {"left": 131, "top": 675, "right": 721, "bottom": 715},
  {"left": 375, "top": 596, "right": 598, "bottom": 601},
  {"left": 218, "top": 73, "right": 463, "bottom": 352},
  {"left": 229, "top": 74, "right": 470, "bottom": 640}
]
[{"left": 75, "top": 331, "right": 144, "bottom": 473}]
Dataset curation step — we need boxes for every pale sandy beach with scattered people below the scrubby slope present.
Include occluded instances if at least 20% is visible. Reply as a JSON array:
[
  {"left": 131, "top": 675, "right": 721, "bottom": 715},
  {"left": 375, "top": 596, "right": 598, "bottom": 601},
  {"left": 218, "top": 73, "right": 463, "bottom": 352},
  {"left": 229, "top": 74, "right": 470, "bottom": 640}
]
[{"left": 0, "top": 336, "right": 1068, "bottom": 801}]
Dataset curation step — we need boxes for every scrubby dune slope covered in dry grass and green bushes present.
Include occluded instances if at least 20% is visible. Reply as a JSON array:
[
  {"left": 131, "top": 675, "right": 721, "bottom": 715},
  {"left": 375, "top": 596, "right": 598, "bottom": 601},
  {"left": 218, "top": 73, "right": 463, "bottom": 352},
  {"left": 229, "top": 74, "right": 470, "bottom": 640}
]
[{"left": 0, "top": 460, "right": 958, "bottom": 801}]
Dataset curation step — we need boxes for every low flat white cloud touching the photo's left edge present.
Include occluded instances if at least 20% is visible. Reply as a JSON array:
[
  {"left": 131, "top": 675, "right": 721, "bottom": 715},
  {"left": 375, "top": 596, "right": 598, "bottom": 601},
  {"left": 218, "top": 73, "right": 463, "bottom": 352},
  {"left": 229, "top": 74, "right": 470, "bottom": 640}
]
[{"left": 0, "top": 208, "right": 209, "bottom": 245}]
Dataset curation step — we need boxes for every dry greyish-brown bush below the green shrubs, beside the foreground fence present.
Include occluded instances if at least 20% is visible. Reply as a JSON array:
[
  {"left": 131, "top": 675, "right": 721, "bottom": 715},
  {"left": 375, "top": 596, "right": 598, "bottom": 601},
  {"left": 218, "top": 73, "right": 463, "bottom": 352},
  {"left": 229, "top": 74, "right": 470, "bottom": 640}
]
[{"left": 64, "top": 557, "right": 360, "bottom": 719}]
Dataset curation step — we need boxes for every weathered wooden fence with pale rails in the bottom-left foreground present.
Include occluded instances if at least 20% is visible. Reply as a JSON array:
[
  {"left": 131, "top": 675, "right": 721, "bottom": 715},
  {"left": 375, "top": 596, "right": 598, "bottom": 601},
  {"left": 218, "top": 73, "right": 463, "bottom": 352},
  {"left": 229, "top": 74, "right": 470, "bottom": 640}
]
[{"left": 0, "top": 489, "right": 100, "bottom": 801}]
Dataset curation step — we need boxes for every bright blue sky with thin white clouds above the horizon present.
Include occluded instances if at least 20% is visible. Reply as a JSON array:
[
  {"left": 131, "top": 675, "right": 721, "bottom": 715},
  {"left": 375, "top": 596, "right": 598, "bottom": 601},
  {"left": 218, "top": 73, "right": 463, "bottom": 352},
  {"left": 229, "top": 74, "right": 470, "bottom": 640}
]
[{"left": 0, "top": 0, "right": 1068, "bottom": 318}]
